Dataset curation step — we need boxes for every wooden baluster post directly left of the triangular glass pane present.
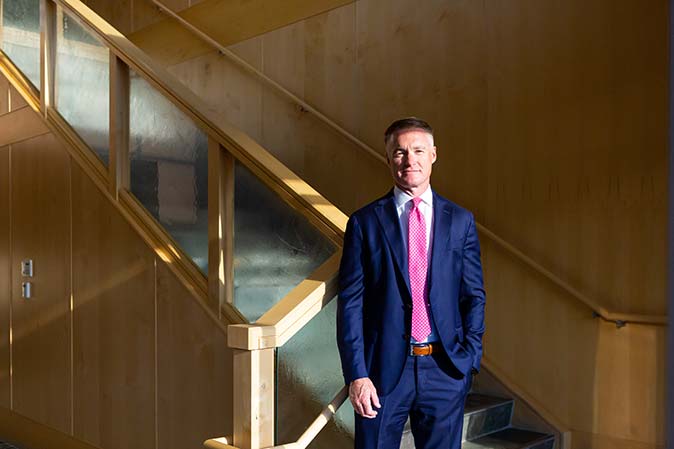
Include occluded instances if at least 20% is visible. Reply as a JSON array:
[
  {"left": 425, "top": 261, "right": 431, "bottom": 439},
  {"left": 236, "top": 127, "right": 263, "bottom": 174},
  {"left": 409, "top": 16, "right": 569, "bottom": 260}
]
[{"left": 208, "top": 137, "right": 234, "bottom": 314}]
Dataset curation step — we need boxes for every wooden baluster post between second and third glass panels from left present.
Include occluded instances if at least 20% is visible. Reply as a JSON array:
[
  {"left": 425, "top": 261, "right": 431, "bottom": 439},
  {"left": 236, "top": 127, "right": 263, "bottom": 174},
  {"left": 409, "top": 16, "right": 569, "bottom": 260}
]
[{"left": 108, "top": 52, "right": 130, "bottom": 199}]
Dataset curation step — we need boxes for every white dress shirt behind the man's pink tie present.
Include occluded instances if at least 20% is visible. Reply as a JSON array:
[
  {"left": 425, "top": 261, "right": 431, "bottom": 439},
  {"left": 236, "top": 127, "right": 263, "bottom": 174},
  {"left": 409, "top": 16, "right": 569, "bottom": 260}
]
[{"left": 393, "top": 186, "right": 438, "bottom": 343}]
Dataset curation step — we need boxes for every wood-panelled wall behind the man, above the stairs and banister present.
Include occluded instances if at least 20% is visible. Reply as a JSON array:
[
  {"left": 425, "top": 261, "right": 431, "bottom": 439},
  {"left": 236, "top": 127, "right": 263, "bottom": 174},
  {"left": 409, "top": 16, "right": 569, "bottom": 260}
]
[{"left": 161, "top": 0, "right": 667, "bottom": 314}]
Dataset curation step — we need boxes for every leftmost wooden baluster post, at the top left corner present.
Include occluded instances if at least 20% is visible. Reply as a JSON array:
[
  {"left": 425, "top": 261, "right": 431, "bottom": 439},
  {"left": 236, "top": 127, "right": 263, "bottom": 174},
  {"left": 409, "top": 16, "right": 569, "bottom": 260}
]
[{"left": 40, "top": 0, "right": 56, "bottom": 117}]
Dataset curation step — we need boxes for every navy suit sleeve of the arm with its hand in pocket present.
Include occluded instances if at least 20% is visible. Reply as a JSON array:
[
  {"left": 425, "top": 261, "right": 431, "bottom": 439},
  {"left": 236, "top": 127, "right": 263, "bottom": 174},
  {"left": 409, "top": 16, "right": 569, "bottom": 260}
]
[{"left": 459, "top": 214, "right": 485, "bottom": 371}]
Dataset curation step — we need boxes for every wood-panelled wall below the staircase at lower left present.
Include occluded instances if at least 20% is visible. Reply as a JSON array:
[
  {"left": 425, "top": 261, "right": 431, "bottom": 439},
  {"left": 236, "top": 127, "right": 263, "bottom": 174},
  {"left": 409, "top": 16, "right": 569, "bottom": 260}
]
[{"left": 0, "top": 75, "right": 232, "bottom": 449}]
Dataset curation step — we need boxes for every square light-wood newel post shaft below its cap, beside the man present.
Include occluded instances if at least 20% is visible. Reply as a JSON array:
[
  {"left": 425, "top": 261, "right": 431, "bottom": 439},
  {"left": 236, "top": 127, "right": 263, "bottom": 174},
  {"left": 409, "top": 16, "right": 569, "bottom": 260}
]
[{"left": 233, "top": 348, "right": 275, "bottom": 449}]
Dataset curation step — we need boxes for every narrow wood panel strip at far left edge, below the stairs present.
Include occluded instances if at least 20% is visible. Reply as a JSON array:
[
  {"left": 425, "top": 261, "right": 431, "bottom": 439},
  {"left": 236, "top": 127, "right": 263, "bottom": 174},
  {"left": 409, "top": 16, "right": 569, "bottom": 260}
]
[{"left": 0, "top": 146, "right": 12, "bottom": 408}]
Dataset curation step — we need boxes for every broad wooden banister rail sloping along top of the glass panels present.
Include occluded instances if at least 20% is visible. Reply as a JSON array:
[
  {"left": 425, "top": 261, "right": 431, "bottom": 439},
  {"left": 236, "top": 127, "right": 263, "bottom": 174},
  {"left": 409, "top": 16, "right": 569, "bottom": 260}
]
[{"left": 54, "top": 0, "right": 347, "bottom": 246}]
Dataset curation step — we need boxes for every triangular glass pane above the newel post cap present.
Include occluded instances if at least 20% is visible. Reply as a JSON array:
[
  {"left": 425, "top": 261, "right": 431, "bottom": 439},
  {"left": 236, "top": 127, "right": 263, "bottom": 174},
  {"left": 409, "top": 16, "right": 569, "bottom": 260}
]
[{"left": 234, "top": 162, "right": 335, "bottom": 321}]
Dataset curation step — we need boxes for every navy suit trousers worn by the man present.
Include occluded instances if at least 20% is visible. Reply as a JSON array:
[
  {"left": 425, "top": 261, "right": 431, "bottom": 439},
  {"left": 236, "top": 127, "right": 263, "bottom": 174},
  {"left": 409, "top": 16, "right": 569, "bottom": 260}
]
[{"left": 355, "top": 352, "right": 472, "bottom": 449}]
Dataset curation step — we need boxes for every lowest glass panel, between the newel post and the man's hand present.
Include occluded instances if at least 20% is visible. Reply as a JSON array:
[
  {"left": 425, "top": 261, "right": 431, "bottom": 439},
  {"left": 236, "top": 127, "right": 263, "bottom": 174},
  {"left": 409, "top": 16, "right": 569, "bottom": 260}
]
[{"left": 276, "top": 299, "right": 354, "bottom": 449}]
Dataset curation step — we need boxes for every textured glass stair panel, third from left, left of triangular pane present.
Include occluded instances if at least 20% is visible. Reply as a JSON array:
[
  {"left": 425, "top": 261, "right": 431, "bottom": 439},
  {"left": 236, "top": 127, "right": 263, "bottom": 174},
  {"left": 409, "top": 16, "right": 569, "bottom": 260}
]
[{"left": 129, "top": 71, "right": 208, "bottom": 273}]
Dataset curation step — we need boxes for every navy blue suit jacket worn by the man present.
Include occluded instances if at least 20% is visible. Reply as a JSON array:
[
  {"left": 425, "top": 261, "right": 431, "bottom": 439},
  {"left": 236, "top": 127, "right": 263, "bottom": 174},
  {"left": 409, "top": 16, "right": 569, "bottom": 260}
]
[{"left": 337, "top": 191, "right": 485, "bottom": 395}]
